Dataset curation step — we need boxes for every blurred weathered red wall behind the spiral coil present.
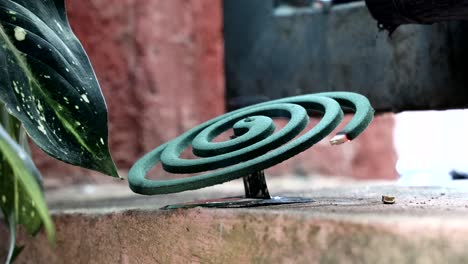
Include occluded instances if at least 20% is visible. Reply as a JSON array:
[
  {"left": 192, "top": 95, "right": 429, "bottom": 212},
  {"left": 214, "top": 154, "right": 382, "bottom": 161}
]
[{"left": 33, "top": 0, "right": 396, "bottom": 186}]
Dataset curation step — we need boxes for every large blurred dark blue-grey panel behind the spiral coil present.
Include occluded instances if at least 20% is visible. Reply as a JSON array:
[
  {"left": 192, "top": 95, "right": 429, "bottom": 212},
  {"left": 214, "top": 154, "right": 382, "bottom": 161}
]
[{"left": 223, "top": 0, "right": 468, "bottom": 113}]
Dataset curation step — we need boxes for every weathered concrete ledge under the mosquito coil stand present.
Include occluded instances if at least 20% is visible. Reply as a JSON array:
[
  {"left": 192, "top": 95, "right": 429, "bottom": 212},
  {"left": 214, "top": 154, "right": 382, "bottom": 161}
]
[{"left": 0, "top": 179, "right": 468, "bottom": 263}]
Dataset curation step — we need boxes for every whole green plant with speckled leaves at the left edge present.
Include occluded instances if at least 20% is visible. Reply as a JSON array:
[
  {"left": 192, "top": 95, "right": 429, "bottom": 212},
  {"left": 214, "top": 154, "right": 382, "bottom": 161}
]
[{"left": 0, "top": 0, "right": 118, "bottom": 262}]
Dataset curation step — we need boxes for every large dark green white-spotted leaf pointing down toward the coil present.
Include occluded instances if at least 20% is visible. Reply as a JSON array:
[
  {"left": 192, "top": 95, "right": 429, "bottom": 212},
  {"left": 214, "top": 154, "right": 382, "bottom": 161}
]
[{"left": 0, "top": 0, "right": 118, "bottom": 176}]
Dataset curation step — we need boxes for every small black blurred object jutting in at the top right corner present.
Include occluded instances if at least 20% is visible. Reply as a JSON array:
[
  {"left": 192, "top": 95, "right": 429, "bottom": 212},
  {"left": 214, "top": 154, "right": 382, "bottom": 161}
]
[{"left": 365, "top": 0, "right": 468, "bottom": 33}]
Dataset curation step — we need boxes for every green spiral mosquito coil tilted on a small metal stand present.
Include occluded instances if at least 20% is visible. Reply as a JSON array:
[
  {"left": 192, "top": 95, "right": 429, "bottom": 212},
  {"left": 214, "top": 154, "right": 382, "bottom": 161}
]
[{"left": 128, "top": 92, "right": 374, "bottom": 195}]
